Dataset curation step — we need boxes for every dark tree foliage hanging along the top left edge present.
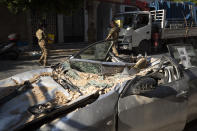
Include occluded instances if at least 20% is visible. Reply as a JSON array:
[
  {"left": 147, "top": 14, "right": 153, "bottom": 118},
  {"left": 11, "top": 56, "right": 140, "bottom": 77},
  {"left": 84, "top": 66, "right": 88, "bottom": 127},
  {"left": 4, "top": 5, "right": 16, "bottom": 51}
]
[{"left": 0, "top": 0, "right": 83, "bottom": 14}]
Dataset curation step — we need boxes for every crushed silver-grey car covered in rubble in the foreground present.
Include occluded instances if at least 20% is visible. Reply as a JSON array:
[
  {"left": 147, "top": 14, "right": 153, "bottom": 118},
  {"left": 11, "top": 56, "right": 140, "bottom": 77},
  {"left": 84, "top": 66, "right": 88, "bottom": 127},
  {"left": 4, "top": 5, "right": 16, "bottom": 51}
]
[{"left": 0, "top": 41, "right": 197, "bottom": 131}]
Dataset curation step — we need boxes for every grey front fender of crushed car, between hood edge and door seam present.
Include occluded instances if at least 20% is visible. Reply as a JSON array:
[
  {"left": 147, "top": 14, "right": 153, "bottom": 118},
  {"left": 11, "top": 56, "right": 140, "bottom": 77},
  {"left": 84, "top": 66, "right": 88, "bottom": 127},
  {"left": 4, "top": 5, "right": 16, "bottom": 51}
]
[{"left": 39, "top": 86, "right": 120, "bottom": 131}]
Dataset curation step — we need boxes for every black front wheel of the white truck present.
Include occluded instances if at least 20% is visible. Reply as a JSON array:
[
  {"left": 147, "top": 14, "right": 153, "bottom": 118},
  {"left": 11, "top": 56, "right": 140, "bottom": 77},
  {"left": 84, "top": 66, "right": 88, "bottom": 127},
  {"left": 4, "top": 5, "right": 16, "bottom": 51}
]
[{"left": 137, "top": 40, "right": 152, "bottom": 55}]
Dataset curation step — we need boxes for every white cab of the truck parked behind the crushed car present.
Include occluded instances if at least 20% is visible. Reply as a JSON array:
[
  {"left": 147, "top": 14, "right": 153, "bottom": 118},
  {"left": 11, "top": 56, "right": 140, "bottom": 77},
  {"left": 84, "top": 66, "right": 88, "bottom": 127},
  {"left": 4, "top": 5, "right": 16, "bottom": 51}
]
[{"left": 113, "top": 11, "right": 152, "bottom": 51}]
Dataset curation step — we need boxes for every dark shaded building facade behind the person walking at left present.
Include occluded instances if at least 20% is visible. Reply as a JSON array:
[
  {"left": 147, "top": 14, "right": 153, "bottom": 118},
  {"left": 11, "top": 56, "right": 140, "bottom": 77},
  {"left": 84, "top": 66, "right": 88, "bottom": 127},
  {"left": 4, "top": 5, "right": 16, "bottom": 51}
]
[{"left": 0, "top": 0, "right": 142, "bottom": 45}]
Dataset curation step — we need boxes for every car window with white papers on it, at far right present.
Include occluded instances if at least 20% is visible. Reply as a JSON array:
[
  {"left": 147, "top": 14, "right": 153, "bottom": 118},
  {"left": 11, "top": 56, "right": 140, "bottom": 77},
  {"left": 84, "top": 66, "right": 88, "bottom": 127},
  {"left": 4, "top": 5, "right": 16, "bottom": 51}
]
[{"left": 168, "top": 45, "right": 197, "bottom": 68}]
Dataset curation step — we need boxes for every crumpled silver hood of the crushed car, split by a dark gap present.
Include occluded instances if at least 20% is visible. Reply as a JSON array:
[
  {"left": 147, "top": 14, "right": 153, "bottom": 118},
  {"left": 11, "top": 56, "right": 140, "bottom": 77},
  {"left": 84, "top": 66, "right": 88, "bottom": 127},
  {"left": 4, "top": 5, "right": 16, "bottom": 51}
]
[{"left": 0, "top": 68, "right": 66, "bottom": 130}]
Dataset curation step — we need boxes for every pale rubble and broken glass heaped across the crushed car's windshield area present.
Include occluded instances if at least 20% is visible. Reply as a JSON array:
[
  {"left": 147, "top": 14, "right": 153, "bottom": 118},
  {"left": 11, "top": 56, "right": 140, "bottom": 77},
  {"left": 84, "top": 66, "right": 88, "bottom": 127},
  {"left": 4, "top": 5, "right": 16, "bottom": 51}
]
[{"left": 52, "top": 62, "right": 159, "bottom": 105}]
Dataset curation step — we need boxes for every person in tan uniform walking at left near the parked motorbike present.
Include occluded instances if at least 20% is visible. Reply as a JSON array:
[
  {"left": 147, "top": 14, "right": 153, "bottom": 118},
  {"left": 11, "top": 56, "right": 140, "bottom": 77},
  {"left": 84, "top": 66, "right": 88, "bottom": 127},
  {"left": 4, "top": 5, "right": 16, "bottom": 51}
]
[{"left": 36, "top": 24, "right": 48, "bottom": 66}]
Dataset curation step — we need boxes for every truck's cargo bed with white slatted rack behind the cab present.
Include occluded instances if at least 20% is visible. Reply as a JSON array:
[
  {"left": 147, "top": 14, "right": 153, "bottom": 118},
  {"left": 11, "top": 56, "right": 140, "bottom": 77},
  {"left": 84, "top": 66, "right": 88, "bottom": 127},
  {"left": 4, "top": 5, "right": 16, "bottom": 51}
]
[{"left": 151, "top": 10, "right": 197, "bottom": 39}]
